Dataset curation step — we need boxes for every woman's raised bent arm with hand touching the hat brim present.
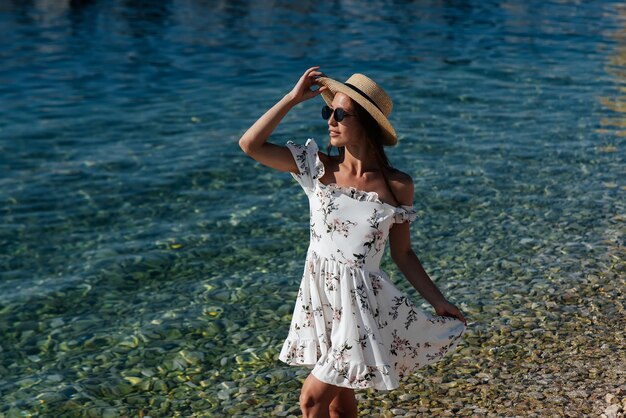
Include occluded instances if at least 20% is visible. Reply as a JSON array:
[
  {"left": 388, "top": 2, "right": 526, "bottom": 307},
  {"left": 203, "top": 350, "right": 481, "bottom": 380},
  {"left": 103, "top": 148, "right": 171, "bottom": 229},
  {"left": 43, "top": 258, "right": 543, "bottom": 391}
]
[{"left": 239, "top": 67, "right": 326, "bottom": 173}]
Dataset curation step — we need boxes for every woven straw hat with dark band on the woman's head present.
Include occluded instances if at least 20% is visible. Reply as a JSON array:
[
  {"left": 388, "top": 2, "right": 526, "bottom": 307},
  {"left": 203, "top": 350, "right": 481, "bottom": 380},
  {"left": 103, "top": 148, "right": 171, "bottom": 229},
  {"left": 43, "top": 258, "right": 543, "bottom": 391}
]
[{"left": 315, "top": 74, "right": 398, "bottom": 145}]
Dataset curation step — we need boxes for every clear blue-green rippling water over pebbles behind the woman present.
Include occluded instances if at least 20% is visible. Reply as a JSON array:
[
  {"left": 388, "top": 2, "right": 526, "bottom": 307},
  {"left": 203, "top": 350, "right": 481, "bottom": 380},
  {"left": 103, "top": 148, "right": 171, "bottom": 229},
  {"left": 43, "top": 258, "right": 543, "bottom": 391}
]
[{"left": 0, "top": 0, "right": 626, "bottom": 416}]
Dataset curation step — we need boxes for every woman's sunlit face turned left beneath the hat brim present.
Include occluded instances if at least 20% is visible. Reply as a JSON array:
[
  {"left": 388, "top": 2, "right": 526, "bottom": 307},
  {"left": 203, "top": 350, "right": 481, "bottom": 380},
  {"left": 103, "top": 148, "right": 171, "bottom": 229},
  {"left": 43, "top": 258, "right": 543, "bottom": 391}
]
[{"left": 328, "top": 93, "right": 367, "bottom": 147}]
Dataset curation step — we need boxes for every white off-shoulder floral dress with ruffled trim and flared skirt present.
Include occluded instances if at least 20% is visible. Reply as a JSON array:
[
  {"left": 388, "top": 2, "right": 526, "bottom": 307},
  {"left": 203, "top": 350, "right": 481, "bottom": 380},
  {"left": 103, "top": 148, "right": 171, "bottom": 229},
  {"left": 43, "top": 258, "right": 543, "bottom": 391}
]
[{"left": 279, "top": 139, "right": 465, "bottom": 390}]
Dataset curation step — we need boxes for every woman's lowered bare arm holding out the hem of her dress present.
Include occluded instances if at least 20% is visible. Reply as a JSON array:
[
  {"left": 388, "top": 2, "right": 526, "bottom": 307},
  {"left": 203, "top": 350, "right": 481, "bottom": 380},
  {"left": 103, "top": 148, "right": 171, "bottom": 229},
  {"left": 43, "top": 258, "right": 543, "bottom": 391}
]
[{"left": 389, "top": 176, "right": 467, "bottom": 325}]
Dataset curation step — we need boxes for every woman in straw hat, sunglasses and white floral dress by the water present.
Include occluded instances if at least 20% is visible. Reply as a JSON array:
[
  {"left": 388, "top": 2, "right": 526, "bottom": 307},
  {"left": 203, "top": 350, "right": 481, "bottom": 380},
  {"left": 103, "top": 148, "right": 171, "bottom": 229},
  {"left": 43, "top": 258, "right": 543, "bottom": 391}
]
[{"left": 239, "top": 67, "right": 466, "bottom": 417}]
